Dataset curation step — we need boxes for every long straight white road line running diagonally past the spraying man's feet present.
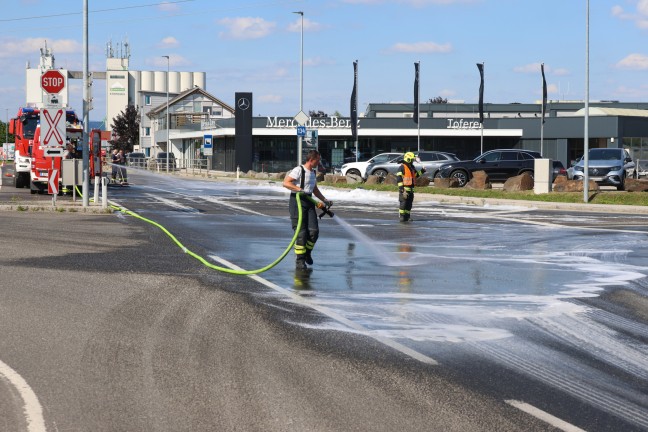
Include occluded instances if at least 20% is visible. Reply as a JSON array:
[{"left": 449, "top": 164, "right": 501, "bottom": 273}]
[{"left": 209, "top": 255, "right": 439, "bottom": 365}]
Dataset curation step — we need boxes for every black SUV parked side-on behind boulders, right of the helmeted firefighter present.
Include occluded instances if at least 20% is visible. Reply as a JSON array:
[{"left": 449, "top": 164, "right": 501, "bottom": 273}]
[{"left": 436, "top": 149, "right": 542, "bottom": 186}]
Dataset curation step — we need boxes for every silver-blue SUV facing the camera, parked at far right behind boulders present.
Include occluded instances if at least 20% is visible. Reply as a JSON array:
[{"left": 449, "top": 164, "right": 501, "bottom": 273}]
[{"left": 573, "top": 148, "right": 635, "bottom": 190}]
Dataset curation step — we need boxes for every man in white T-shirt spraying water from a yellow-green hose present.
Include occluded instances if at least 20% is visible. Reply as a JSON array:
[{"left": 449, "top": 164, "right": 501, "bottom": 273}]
[{"left": 283, "top": 150, "right": 333, "bottom": 270}]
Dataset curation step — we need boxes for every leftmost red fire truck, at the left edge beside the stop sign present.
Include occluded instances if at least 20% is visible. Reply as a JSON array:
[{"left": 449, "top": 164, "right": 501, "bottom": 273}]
[{"left": 9, "top": 107, "right": 40, "bottom": 188}]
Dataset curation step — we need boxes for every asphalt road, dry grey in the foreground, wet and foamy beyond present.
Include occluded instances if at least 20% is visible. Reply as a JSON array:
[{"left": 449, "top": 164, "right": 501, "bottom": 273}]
[{"left": 0, "top": 164, "right": 648, "bottom": 431}]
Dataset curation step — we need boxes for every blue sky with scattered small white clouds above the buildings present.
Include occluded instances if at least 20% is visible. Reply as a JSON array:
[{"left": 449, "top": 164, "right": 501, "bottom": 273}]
[{"left": 0, "top": 0, "right": 648, "bottom": 121}]
